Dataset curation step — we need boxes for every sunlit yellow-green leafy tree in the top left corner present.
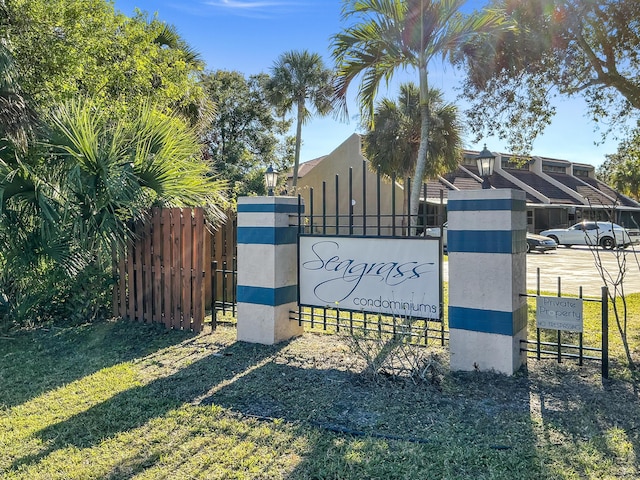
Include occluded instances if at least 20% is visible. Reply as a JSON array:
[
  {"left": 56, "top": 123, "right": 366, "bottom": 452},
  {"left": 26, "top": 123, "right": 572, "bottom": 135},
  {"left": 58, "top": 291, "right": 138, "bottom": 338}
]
[{"left": 5, "top": 0, "right": 210, "bottom": 124}]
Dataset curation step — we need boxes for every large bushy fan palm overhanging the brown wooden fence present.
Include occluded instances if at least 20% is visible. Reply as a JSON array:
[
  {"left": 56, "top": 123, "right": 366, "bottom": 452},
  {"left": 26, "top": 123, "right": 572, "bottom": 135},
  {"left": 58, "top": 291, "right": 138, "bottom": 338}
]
[{"left": 0, "top": 96, "right": 226, "bottom": 324}]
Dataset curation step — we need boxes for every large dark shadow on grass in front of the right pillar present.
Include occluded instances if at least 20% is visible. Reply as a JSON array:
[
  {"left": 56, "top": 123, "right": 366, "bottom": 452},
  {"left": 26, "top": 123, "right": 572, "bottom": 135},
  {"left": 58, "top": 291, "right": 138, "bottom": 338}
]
[{"left": 203, "top": 362, "right": 549, "bottom": 479}]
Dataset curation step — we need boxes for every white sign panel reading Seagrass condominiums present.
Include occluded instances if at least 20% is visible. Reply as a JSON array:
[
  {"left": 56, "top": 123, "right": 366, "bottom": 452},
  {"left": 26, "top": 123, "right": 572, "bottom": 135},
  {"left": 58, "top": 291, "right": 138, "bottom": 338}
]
[{"left": 299, "top": 236, "right": 440, "bottom": 319}]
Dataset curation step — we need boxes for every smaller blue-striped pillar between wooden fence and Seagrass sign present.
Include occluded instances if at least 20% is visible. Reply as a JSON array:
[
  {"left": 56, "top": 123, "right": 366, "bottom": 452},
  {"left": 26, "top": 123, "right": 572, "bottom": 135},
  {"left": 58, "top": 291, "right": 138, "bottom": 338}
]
[{"left": 237, "top": 197, "right": 303, "bottom": 345}]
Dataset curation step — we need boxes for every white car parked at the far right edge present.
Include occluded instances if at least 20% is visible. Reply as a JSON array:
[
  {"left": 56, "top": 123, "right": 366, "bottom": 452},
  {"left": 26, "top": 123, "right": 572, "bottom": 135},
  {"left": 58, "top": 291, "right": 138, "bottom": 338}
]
[{"left": 540, "top": 220, "right": 640, "bottom": 249}]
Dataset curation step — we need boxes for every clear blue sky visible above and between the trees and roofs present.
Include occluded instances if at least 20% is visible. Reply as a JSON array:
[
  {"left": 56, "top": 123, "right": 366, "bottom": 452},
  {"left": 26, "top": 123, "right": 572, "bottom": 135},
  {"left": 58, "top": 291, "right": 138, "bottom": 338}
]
[{"left": 114, "top": 0, "right": 617, "bottom": 165}]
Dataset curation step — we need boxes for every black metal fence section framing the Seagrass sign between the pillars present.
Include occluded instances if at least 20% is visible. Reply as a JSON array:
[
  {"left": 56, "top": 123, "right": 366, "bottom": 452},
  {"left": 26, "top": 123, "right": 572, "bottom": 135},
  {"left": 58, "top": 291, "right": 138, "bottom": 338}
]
[{"left": 290, "top": 166, "right": 448, "bottom": 346}]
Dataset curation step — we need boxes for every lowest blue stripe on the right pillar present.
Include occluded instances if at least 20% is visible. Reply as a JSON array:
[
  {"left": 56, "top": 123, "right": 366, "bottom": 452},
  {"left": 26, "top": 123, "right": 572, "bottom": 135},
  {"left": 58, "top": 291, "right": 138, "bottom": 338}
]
[{"left": 449, "top": 304, "right": 527, "bottom": 335}]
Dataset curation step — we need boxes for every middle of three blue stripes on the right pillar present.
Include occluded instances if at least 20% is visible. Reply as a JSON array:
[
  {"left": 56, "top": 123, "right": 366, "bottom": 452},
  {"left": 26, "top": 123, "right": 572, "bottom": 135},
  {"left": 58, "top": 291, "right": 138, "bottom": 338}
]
[{"left": 447, "top": 230, "right": 526, "bottom": 253}]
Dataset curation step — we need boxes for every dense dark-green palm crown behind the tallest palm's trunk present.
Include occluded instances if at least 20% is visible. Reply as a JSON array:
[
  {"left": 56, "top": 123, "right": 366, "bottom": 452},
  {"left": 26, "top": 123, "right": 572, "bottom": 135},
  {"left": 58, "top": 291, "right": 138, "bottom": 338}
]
[{"left": 364, "top": 83, "right": 462, "bottom": 178}]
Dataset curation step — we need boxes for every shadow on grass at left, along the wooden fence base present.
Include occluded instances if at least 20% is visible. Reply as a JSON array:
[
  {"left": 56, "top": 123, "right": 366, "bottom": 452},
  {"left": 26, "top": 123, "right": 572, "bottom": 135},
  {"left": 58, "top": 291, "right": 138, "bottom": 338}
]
[{"left": 0, "top": 320, "right": 194, "bottom": 407}]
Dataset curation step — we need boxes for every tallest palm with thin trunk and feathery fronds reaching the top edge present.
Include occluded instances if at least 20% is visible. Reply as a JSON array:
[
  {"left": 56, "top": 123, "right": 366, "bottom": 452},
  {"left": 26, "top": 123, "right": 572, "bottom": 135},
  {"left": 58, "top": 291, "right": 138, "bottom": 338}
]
[{"left": 333, "top": 0, "right": 502, "bottom": 223}]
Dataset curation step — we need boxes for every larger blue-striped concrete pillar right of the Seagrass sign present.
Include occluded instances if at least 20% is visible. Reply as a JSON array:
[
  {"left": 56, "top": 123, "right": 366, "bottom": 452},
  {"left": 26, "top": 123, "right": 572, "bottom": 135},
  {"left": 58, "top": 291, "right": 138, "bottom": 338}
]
[{"left": 447, "top": 189, "right": 527, "bottom": 375}]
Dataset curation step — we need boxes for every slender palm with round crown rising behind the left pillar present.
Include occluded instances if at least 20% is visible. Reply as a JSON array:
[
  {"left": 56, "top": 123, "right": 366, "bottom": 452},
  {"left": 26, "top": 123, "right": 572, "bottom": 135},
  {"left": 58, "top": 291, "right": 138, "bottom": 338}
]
[{"left": 267, "top": 50, "right": 333, "bottom": 190}]
